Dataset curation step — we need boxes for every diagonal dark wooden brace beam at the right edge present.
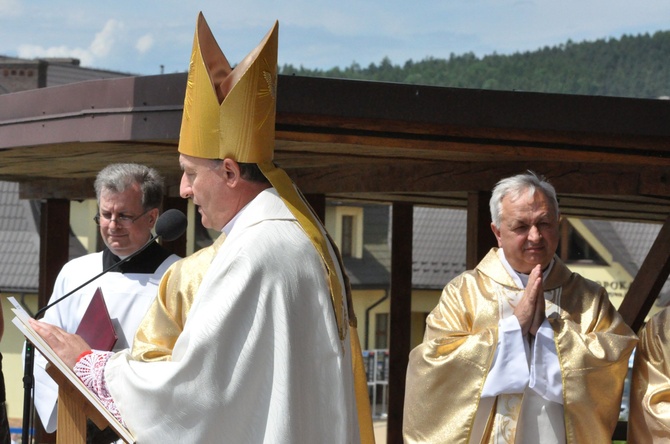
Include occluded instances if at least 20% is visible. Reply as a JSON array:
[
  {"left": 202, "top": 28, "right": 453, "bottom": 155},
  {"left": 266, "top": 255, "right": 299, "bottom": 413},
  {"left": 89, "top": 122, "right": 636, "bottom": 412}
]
[{"left": 619, "top": 216, "right": 670, "bottom": 332}]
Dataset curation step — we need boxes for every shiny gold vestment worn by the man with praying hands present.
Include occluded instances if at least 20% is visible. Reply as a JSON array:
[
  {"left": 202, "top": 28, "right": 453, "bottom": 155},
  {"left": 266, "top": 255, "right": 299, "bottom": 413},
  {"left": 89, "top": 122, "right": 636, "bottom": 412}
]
[{"left": 403, "top": 248, "right": 636, "bottom": 443}]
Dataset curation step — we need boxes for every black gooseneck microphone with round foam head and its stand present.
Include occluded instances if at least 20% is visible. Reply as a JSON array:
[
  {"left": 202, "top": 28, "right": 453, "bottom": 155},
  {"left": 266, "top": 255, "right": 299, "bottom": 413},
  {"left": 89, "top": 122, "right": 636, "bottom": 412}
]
[{"left": 21, "top": 208, "right": 188, "bottom": 442}]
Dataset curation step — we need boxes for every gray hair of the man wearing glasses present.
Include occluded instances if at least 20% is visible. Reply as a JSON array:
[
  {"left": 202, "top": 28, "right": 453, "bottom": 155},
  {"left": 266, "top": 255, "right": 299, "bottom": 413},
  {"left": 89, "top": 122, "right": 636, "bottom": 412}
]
[{"left": 94, "top": 163, "right": 163, "bottom": 210}]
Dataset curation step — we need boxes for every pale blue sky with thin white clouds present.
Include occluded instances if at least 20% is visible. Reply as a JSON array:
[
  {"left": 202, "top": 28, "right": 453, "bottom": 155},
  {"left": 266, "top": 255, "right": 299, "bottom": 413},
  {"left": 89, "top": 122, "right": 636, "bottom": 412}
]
[{"left": 0, "top": 0, "right": 670, "bottom": 75}]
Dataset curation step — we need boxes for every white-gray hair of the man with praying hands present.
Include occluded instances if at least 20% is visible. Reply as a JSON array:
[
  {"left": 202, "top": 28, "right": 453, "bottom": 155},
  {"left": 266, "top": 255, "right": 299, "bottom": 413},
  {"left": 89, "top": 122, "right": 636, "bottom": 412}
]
[{"left": 489, "top": 170, "right": 559, "bottom": 228}]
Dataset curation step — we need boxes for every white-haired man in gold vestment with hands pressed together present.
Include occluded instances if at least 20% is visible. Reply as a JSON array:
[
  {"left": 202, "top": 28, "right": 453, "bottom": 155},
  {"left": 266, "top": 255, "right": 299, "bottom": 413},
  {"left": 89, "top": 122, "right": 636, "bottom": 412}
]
[{"left": 403, "top": 172, "right": 636, "bottom": 444}]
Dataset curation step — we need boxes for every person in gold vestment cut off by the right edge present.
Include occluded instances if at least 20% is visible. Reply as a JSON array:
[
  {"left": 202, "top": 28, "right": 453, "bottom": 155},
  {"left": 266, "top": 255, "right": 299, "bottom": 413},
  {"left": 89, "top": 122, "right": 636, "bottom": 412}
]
[{"left": 628, "top": 308, "right": 670, "bottom": 444}]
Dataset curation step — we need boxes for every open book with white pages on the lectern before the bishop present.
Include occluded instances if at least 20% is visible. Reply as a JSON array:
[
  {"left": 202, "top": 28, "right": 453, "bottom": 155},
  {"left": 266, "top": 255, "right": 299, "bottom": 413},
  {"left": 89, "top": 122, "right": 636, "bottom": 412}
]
[{"left": 8, "top": 297, "right": 135, "bottom": 443}]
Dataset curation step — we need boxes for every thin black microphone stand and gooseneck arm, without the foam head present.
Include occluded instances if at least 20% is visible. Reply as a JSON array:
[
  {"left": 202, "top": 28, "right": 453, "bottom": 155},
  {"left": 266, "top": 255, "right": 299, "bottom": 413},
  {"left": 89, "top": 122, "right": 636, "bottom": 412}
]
[{"left": 21, "top": 234, "right": 161, "bottom": 444}]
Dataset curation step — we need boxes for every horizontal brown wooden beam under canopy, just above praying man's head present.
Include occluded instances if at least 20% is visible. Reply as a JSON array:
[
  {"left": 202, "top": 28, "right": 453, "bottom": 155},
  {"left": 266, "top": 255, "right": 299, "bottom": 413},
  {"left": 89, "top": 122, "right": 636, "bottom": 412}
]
[{"left": 286, "top": 161, "right": 670, "bottom": 198}]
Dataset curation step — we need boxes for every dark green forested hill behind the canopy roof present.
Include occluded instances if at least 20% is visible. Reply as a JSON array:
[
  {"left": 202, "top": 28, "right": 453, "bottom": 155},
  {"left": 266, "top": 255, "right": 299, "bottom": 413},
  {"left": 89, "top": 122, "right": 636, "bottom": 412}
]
[{"left": 279, "top": 31, "right": 670, "bottom": 98}]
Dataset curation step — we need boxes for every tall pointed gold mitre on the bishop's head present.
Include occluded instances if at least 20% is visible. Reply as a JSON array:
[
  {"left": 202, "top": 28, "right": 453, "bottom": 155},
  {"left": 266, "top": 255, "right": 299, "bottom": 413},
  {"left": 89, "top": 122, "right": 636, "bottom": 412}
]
[{"left": 179, "top": 13, "right": 279, "bottom": 163}]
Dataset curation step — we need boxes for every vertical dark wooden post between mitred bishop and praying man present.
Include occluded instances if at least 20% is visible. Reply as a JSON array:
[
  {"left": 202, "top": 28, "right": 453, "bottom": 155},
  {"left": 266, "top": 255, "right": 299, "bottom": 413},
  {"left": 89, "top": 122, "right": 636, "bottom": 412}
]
[{"left": 386, "top": 203, "right": 414, "bottom": 444}]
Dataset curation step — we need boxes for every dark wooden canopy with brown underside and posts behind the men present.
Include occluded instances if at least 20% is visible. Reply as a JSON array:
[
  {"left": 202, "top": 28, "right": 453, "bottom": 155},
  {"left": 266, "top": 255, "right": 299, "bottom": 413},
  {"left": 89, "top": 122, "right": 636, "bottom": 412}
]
[{"left": 0, "top": 74, "right": 670, "bottom": 442}]
